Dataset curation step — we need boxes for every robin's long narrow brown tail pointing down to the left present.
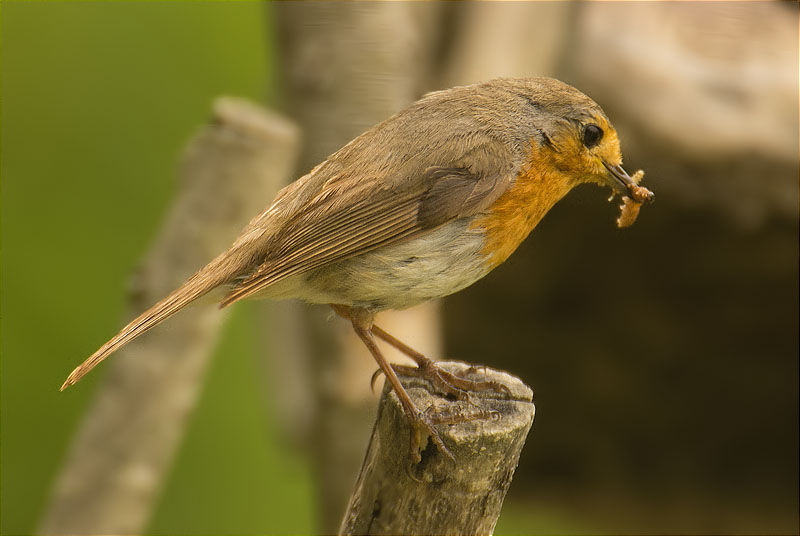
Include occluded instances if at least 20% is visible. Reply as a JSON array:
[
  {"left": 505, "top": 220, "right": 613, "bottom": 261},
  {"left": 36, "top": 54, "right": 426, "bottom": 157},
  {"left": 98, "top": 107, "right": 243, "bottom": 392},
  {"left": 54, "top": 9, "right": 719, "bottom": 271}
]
[{"left": 61, "top": 254, "right": 232, "bottom": 391}]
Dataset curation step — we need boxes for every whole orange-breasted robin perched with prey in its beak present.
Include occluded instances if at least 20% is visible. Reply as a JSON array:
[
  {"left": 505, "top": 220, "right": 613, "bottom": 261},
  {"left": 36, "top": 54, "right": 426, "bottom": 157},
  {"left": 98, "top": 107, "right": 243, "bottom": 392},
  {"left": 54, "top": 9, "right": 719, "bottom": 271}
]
[{"left": 61, "top": 78, "right": 652, "bottom": 460}]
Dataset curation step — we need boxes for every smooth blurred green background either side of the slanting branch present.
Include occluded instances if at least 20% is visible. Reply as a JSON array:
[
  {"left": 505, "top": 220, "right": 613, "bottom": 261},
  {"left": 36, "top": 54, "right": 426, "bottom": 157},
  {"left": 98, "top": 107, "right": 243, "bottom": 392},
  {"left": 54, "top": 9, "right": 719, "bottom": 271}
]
[{"left": 0, "top": 2, "right": 314, "bottom": 534}]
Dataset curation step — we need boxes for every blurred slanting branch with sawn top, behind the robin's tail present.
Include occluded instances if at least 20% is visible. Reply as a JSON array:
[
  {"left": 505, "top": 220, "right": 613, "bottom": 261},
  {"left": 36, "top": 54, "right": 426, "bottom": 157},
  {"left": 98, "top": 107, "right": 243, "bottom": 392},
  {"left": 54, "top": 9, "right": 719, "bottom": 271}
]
[{"left": 39, "top": 98, "right": 299, "bottom": 534}]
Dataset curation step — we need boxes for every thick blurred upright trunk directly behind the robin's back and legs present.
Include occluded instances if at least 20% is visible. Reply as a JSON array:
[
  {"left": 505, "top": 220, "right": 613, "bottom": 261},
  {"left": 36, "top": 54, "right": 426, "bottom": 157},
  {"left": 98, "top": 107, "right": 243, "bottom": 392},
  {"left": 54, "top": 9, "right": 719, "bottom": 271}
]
[{"left": 269, "top": 2, "right": 439, "bottom": 533}]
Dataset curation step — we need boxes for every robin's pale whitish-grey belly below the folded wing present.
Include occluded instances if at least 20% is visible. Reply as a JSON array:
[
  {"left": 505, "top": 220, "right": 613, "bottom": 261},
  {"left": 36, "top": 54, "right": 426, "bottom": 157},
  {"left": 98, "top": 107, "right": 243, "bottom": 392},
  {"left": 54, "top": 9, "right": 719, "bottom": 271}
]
[{"left": 260, "top": 220, "right": 491, "bottom": 311}]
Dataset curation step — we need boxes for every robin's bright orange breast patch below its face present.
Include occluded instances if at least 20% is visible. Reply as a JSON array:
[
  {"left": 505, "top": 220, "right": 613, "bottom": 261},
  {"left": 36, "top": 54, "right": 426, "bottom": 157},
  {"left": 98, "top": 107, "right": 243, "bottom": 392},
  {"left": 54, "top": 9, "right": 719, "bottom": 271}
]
[{"left": 471, "top": 142, "right": 577, "bottom": 269}]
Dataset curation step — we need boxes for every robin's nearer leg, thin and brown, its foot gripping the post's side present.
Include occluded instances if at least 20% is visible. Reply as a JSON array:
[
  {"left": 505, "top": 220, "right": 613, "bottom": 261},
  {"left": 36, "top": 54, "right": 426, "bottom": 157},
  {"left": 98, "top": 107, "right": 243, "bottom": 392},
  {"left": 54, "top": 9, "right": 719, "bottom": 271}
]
[{"left": 332, "top": 305, "right": 455, "bottom": 463}]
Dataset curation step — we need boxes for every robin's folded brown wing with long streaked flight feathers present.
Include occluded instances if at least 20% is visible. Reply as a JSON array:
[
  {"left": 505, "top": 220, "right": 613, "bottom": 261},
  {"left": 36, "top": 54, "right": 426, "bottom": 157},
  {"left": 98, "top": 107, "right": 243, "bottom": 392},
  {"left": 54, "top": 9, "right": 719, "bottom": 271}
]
[{"left": 220, "top": 147, "right": 514, "bottom": 307}]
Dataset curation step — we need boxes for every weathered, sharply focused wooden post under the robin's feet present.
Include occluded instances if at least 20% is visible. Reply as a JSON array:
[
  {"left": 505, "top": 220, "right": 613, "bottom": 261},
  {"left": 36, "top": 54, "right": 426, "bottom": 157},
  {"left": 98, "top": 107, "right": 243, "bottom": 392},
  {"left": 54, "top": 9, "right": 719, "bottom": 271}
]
[{"left": 340, "top": 362, "right": 534, "bottom": 534}]
